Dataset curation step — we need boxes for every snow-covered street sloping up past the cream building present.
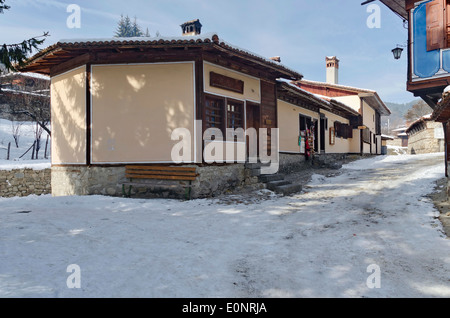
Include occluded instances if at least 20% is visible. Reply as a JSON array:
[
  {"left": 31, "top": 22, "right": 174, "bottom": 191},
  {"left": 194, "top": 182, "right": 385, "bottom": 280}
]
[{"left": 0, "top": 154, "right": 450, "bottom": 298}]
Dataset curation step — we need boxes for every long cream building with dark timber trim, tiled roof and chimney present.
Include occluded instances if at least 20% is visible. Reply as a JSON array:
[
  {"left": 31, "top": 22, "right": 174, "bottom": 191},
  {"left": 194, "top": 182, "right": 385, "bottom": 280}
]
[{"left": 18, "top": 20, "right": 390, "bottom": 198}]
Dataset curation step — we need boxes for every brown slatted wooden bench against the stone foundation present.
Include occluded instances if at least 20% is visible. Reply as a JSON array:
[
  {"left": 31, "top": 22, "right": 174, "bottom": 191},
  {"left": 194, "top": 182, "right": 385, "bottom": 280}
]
[{"left": 122, "top": 165, "right": 198, "bottom": 200}]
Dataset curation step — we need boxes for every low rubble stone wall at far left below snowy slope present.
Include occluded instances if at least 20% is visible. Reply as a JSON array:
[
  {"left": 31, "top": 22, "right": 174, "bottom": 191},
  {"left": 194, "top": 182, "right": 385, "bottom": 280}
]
[{"left": 0, "top": 169, "right": 51, "bottom": 198}]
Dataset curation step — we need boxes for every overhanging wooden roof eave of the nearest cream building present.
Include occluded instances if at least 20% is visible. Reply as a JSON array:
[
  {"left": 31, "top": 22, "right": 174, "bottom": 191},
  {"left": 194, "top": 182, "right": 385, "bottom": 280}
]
[{"left": 19, "top": 36, "right": 303, "bottom": 80}]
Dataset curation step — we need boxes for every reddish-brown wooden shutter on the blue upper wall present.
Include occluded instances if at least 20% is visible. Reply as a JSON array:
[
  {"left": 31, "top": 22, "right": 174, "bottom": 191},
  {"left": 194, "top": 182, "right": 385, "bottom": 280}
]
[{"left": 426, "top": 0, "right": 447, "bottom": 51}]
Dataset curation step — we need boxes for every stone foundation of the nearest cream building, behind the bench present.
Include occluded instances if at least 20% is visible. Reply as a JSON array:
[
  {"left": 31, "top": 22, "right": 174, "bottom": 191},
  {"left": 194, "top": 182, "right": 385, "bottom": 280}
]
[{"left": 51, "top": 164, "right": 258, "bottom": 199}]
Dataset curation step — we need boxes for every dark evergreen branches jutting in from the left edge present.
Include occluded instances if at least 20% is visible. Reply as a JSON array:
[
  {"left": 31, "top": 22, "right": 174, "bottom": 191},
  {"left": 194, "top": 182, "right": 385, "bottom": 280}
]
[{"left": 0, "top": 0, "right": 49, "bottom": 71}]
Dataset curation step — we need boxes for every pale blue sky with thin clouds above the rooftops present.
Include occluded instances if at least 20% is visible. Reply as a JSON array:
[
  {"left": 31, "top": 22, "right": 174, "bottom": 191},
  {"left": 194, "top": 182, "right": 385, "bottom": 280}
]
[{"left": 0, "top": 0, "right": 414, "bottom": 103}]
